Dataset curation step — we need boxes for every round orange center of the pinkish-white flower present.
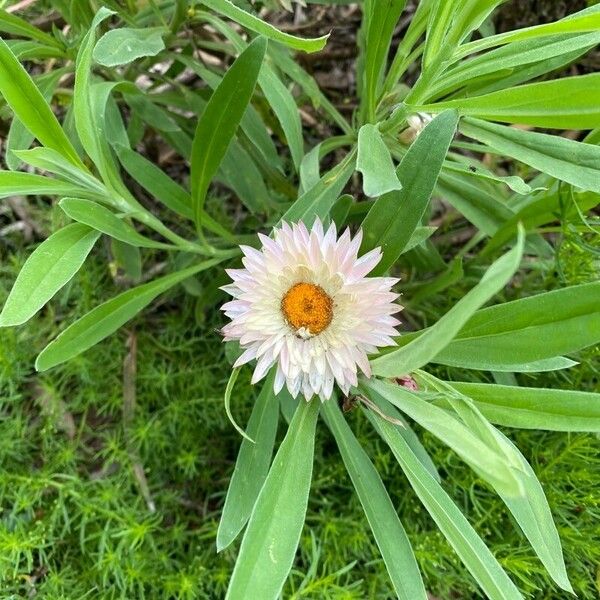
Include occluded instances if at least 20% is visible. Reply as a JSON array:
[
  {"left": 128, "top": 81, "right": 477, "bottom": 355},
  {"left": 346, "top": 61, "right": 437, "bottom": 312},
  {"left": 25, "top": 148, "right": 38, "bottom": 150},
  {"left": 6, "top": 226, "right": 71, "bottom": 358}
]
[{"left": 281, "top": 283, "right": 333, "bottom": 335}]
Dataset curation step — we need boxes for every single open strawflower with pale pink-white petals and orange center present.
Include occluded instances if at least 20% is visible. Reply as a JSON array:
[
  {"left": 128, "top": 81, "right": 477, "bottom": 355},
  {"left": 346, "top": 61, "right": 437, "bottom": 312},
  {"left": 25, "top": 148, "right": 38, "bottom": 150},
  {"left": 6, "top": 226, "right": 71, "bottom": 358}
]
[{"left": 222, "top": 220, "right": 402, "bottom": 400}]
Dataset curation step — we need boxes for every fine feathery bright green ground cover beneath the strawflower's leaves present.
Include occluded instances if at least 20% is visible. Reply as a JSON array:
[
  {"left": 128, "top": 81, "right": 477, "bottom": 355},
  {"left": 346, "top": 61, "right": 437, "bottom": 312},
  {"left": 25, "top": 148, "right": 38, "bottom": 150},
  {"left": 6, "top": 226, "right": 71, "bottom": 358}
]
[{"left": 0, "top": 209, "right": 600, "bottom": 600}]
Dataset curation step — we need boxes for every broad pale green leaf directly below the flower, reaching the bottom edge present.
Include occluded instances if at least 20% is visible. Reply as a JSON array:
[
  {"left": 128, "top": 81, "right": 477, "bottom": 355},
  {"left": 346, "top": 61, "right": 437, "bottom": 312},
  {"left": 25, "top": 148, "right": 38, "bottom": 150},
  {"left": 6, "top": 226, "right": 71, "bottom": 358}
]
[{"left": 226, "top": 399, "right": 321, "bottom": 600}]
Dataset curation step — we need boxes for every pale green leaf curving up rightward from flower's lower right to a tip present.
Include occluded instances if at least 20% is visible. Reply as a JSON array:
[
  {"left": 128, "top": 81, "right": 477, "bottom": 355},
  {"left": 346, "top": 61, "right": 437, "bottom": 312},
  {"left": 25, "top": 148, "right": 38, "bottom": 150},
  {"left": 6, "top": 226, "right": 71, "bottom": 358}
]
[{"left": 371, "top": 230, "right": 524, "bottom": 377}]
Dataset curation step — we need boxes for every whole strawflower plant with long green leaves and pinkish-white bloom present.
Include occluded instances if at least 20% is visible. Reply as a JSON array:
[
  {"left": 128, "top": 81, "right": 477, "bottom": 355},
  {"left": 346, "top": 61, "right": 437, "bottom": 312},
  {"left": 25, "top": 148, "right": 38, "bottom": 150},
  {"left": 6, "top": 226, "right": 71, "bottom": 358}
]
[{"left": 0, "top": 0, "right": 600, "bottom": 600}]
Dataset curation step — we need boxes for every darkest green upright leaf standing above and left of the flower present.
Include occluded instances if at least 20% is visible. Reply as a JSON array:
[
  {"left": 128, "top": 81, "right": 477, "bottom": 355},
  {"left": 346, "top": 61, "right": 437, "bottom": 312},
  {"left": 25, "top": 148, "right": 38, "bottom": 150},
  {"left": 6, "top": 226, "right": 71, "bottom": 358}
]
[{"left": 190, "top": 38, "right": 267, "bottom": 227}]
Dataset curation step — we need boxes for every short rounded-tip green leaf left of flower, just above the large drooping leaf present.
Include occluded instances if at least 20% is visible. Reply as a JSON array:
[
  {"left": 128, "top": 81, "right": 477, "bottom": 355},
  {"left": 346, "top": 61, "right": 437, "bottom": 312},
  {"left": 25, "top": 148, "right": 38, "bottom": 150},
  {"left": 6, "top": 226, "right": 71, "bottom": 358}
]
[{"left": 59, "top": 198, "right": 171, "bottom": 248}]
